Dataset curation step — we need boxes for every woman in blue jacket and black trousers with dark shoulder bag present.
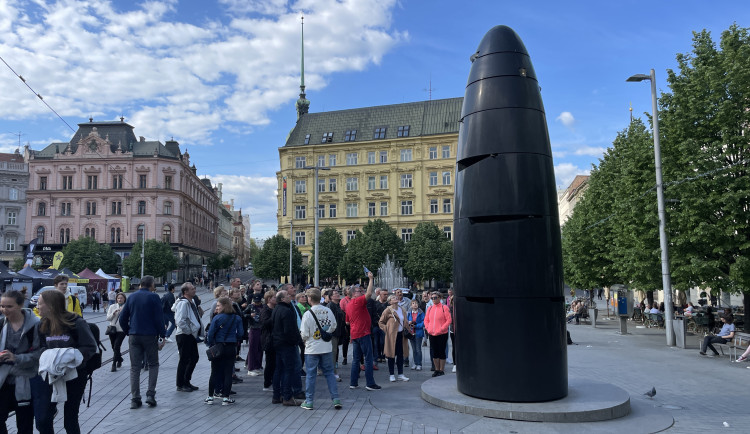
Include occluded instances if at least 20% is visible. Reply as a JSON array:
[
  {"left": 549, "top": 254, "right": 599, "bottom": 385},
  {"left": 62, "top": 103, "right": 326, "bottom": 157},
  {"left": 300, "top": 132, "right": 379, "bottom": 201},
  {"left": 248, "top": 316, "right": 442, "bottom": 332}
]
[{"left": 204, "top": 297, "right": 243, "bottom": 405}]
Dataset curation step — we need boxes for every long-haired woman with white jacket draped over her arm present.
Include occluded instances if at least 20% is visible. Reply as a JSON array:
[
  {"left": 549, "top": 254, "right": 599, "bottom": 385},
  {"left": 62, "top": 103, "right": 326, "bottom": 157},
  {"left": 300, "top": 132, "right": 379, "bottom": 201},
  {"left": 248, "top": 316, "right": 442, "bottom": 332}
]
[{"left": 37, "top": 291, "right": 97, "bottom": 434}]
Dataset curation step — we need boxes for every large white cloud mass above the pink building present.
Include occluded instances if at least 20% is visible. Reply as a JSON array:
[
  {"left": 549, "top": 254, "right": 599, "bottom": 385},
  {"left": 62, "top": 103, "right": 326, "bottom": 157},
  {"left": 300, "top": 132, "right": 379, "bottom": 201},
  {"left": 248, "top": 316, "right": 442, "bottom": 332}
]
[{"left": 0, "top": 0, "right": 408, "bottom": 145}]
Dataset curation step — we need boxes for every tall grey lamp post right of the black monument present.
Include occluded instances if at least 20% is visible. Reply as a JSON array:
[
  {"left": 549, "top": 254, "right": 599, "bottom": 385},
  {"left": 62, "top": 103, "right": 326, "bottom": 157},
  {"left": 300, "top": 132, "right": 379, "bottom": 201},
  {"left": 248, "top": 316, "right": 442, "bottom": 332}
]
[{"left": 626, "top": 69, "right": 675, "bottom": 346}]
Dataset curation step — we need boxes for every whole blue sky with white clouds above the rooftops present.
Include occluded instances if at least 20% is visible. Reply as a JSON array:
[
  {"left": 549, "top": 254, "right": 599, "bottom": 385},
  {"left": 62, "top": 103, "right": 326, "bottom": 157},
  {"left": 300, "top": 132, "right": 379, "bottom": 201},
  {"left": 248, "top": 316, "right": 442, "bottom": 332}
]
[{"left": 0, "top": 0, "right": 750, "bottom": 238}]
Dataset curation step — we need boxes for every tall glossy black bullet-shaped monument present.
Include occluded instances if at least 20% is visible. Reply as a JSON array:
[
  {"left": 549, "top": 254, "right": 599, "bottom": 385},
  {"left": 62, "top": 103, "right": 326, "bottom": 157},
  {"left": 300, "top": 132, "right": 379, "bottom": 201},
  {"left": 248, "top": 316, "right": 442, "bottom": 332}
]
[{"left": 453, "top": 26, "right": 568, "bottom": 402}]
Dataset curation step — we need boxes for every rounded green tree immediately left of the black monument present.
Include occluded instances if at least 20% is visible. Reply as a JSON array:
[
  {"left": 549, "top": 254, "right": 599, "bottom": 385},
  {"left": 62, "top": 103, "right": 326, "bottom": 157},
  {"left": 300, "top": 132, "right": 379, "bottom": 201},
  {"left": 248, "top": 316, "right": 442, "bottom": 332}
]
[{"left": 404, "top": 222, "right": 453, "bottom": 282}]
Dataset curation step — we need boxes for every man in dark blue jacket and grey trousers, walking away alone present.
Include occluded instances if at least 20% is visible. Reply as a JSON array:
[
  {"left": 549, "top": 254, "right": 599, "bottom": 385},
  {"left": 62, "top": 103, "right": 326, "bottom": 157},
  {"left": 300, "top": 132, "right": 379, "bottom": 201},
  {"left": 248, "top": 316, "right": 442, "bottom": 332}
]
[{"left": 120, "top": 276, "right": 165, "bottom": 409}]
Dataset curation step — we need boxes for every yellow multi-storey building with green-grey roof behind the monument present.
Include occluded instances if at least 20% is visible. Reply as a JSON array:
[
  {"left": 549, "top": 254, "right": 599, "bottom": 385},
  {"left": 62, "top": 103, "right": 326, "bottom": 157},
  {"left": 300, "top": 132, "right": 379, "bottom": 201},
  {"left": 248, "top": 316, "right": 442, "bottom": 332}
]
[{"left": 276, "top": 98, "right": 463, "bottom": 264}]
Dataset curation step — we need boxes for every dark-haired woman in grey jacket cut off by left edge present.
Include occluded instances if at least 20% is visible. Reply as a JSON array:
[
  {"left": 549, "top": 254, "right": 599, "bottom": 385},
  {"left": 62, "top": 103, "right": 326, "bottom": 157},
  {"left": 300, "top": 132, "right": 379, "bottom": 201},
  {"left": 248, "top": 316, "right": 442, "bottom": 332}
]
[{"left": 0, "top": 291, "right": 44, "bottom": 434}]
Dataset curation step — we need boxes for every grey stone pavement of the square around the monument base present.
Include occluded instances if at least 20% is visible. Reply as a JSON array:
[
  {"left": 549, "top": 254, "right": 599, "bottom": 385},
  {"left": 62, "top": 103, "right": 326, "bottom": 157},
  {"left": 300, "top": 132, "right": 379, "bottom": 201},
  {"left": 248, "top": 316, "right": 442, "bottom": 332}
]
[{"left": 8, "top": 289, "right": 750, "bottom": 434}]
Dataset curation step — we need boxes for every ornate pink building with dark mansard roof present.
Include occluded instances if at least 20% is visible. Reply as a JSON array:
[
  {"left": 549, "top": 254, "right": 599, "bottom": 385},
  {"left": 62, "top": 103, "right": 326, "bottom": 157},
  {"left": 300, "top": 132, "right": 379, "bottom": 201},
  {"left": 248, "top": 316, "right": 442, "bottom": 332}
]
[{"left": 26, "top": 119, "right": 218, "bottom": 280}]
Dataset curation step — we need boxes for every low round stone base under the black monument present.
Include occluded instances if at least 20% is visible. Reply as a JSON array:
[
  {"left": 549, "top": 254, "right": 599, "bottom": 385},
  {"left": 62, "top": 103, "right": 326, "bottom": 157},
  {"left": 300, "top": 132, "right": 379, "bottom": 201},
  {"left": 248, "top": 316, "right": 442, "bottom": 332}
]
[{"left": 422, "top": 375, "right": 630, "bottom": 422}]
